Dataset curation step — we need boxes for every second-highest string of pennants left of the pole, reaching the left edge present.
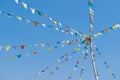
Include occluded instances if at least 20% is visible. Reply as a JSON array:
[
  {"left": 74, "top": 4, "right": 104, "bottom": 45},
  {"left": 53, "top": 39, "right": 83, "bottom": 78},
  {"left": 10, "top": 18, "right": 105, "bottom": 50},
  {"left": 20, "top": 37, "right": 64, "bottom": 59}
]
[{"left": 0, "top": 11, "right": 86, "bottom": 36}]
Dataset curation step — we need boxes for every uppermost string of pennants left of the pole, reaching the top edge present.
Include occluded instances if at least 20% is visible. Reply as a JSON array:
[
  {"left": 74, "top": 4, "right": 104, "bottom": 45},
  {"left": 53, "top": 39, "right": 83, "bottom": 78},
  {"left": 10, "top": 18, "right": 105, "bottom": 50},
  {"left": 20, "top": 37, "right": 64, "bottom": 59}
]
[{"left": 15, "top": 0, "right": 84, "bottom": 36}]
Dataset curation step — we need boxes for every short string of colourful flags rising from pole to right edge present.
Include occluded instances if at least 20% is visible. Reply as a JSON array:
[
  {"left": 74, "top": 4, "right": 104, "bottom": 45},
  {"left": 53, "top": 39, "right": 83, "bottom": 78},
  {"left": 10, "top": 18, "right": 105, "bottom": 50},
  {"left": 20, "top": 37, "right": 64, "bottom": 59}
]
[{"left": 93, "top": 23, "right": 120, "bottom": 37}]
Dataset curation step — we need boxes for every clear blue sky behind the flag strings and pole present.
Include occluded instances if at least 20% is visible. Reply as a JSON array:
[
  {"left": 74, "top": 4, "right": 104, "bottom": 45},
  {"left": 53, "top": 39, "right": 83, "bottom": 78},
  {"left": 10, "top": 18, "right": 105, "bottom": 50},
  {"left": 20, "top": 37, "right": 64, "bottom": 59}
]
[{"left": 0, "top": 0, "right": 120, "bottom": 80}]
